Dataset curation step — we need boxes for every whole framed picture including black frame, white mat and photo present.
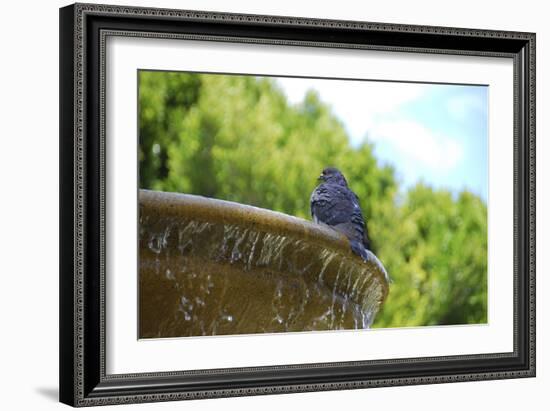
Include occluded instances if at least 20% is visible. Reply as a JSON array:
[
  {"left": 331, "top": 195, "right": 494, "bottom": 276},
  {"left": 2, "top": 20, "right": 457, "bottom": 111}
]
[{"left": 60, "top": 4, "right": 535, "bottom": 406}]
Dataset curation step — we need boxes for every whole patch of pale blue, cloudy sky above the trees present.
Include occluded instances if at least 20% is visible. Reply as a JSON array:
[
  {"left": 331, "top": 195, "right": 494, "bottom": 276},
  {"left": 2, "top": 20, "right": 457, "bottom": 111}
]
[{"left": 276, "top": 78, "right": 488, "bottom": 201}]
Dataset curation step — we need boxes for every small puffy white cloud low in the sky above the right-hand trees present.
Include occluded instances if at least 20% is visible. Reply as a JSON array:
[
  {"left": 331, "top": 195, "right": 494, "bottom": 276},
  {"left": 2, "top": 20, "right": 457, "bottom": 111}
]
[{"left": 369, "top": 120, "right": 464, "bottom": 173}]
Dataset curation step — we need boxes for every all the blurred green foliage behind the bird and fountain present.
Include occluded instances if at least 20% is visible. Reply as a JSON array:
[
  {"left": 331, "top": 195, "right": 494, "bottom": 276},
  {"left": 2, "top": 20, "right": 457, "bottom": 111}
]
[{"left": 139, "top": 71, "right": 487, "bottom": 327}]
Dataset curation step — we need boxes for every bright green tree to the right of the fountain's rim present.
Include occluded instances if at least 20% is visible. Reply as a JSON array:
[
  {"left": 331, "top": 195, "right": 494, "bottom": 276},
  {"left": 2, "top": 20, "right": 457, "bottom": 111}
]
[{"left": 376, "top": 184, "right": 487, "bottom": 327}]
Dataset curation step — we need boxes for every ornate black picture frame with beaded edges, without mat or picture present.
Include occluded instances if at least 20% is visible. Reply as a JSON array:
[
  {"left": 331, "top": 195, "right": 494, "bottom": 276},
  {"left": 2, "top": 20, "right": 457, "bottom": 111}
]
[{"left": 60, "top": 4, "right": 535, "bottom": 406}]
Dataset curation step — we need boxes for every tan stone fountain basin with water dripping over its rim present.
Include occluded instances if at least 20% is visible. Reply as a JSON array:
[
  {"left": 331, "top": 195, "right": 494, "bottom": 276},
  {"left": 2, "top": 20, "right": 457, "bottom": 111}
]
[{"left": 139, "top": 190, "right": 388, "bottom": 338}]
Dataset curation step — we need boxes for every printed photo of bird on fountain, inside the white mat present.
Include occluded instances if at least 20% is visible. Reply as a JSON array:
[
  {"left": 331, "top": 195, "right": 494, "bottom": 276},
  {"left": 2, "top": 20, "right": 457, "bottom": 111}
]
[{"left": 137, "top": 69, "right": 489, "bottom": 339}]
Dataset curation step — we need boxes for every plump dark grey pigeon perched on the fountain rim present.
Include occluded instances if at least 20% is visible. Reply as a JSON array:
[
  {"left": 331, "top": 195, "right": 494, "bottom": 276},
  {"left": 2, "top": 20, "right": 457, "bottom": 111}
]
[{"left": 309, "top": 167, "right": 370, "bottom": 261}]
